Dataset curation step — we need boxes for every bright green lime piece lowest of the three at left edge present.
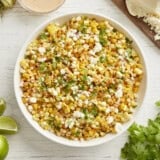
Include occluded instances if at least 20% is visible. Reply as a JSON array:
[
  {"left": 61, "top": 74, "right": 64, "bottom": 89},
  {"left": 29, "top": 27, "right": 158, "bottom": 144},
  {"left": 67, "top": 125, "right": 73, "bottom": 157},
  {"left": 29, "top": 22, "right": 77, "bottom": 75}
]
[{"left": 0, "top": 135, "right": 9, "bottom": 160}]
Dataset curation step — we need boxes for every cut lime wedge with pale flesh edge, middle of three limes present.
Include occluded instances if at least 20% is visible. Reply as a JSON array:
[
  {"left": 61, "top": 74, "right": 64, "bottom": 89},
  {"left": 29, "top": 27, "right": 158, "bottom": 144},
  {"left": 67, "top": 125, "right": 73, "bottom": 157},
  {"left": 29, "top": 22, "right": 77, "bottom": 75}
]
[{"left": 0, "top": 116, "right": 18, "bottom": 134}]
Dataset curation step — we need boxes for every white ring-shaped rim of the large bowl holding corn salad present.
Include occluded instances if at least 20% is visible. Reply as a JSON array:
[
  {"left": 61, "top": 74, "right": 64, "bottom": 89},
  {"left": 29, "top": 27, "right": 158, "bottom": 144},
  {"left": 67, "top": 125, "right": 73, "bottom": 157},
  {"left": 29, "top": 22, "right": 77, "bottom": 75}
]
[{"left": 13, "top": 12, "right": 148, "bottom": 147}]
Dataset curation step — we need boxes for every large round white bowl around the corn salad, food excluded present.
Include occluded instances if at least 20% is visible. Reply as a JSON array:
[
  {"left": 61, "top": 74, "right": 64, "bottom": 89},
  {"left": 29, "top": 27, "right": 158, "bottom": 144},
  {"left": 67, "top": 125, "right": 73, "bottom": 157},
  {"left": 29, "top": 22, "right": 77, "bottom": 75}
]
[{"left": 14, "top": 13, "right": 147, "bottom": 147}]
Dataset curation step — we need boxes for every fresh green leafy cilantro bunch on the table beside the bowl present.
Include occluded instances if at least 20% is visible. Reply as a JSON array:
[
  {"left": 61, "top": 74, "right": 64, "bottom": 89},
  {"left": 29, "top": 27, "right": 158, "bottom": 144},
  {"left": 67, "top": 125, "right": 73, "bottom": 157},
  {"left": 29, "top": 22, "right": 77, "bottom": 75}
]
[{"left": 121, "top": 101, "right": 160, "bottom": 160}]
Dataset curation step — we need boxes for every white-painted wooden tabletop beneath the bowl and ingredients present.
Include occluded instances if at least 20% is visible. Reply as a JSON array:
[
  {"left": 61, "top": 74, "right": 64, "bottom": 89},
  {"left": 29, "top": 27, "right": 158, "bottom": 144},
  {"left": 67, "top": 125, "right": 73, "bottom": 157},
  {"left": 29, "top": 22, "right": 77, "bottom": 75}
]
[{"left": 0, "top": 0, "right": 160, "bottom": 160}]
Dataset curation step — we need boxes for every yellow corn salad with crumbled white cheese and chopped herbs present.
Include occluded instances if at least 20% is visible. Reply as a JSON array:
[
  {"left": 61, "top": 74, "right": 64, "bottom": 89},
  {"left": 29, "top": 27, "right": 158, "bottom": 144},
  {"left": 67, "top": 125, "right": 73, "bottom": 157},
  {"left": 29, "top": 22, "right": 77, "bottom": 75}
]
[{"left": 20, "top": 16, "right": 143, "bottom": 140}]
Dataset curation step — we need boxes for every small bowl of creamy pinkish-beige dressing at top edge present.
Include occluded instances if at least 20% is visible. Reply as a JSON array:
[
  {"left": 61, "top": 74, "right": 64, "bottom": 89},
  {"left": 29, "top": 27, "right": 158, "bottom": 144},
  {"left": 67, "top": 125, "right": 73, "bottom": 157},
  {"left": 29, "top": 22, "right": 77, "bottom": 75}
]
[{"left": 18, "top": 0, "right": 65, "bottom": 13}]
